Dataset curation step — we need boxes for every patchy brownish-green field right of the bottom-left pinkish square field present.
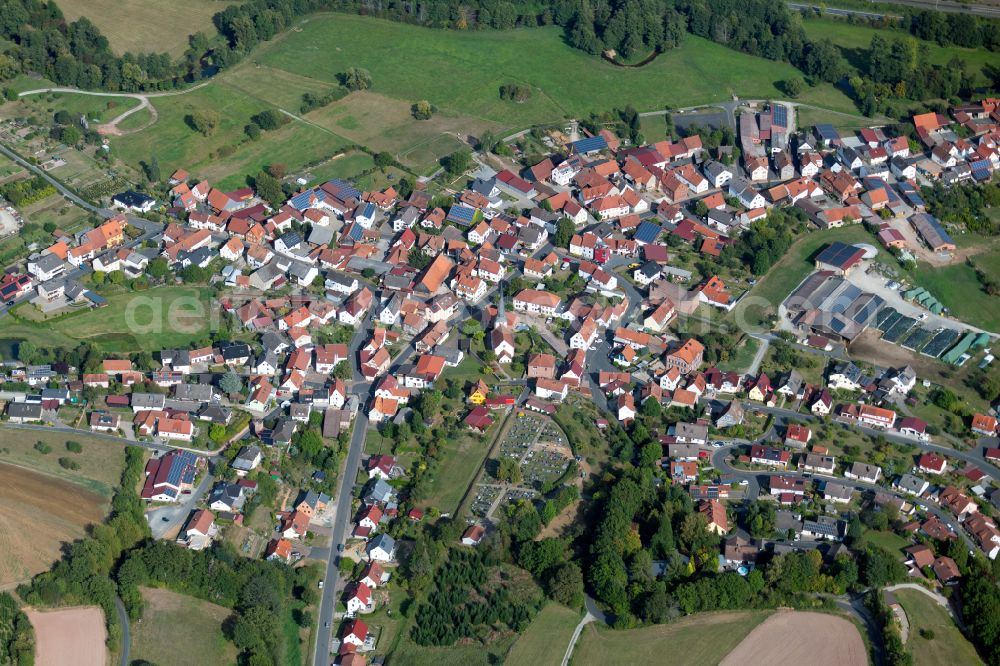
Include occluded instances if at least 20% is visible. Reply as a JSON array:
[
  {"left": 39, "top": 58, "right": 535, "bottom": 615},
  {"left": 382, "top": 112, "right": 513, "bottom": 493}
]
[{"left": 130, "top": 587, "right": 237, "bottom": 666}]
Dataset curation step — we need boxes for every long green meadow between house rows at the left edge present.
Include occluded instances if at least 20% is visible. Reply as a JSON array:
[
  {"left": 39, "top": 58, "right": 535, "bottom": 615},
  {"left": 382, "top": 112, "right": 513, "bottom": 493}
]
[{"left": 0, "top": 286, "right": 218, "bottom": 353}]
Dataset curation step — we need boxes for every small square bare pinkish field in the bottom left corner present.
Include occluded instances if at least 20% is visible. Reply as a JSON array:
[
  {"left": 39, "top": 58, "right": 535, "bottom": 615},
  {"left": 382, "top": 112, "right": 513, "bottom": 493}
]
[{"left": 25, "top": 606, "right": 108, "bottom": 666}]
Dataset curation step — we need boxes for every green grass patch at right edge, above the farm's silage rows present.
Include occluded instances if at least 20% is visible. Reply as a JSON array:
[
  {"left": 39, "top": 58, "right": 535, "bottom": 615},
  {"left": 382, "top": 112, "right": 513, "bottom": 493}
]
[{"left": 912, "top": 250, "right": 1000, "bottom": 331}]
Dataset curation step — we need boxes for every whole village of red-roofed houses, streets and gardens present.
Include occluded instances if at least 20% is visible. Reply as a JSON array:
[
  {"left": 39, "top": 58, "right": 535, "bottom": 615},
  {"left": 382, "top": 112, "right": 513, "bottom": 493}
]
[{"left": 0, "top": 59, "right": 1000, "bottom": 664}]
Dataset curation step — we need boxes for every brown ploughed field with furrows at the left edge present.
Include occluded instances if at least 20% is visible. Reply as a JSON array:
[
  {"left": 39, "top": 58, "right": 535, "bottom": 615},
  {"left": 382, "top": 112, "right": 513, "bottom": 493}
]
[{"left": 0, "top": 460, "right": 106, "bottom": 585}]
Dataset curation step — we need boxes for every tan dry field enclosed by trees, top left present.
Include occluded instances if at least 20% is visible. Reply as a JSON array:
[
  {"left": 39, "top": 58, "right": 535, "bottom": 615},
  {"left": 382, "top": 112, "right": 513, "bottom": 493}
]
[{"left": 59, "top": 0, "right": 233, "bottom": 57}]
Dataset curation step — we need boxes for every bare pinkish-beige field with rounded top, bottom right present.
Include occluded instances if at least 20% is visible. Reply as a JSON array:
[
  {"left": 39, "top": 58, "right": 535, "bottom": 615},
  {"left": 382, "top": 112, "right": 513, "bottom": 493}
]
[{"left": 721, "top": 611, "right": 868, "bottom": 666}]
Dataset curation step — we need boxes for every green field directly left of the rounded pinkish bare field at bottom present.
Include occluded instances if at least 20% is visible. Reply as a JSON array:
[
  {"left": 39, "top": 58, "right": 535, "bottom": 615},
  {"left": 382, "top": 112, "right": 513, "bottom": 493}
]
[{"left": 573, "top": 612, "right": 769, "bottom": 666}]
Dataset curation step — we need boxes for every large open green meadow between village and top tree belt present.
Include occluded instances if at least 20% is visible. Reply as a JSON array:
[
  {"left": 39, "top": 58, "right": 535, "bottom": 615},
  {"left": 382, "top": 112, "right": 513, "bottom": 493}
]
[{"left": 105, "top": 14, "right": 854, "bottom": 180}]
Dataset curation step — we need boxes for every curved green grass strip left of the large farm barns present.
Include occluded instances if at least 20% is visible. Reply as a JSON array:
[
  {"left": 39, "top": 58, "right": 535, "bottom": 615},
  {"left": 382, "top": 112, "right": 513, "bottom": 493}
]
[{"left": 734, "top": 224, "right": 875, "bottom": 324}]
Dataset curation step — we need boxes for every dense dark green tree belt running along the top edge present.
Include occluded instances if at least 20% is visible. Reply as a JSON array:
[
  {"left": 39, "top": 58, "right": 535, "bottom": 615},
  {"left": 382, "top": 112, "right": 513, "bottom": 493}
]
[{"left": 0, "top": 0, "right": 1000, "bottom": 120}]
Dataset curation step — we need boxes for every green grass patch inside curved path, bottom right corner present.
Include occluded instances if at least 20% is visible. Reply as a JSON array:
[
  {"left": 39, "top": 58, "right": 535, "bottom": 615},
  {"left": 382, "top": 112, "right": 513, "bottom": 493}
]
[{"left": 892, "top": 590, "right": 983, "bottom": 666}]
